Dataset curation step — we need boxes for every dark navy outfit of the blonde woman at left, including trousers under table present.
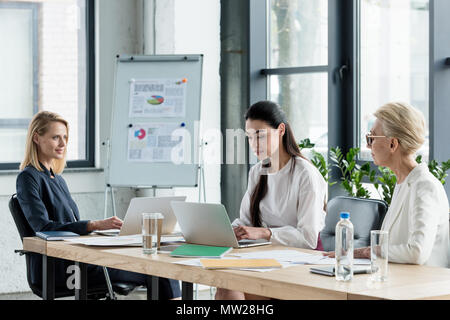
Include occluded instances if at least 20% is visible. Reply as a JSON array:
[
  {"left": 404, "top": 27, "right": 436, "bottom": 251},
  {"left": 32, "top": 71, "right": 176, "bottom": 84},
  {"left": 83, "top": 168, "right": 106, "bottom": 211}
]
[{"left": 16, "top": 164, "right": 180, "bottom": 299}]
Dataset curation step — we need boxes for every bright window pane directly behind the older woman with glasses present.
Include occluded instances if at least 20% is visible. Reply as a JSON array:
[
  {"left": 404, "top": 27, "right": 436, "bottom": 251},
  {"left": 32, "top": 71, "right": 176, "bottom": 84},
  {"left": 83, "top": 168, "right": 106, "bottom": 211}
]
[{"left": 359, "top": 0, "right": 430, "bottom": 160}]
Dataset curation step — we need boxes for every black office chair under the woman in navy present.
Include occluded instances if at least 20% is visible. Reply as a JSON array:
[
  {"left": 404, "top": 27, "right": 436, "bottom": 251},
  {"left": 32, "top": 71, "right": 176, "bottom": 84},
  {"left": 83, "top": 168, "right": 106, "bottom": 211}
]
[{"left": 9, "top": 194, "right": 136, "bottom": 300}]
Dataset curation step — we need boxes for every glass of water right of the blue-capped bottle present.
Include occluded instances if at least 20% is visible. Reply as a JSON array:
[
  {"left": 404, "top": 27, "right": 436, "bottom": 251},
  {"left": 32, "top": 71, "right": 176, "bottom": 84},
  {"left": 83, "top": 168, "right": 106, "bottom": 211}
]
[{"left": 370, "top": 230, "right": 389, "bottom": 281}]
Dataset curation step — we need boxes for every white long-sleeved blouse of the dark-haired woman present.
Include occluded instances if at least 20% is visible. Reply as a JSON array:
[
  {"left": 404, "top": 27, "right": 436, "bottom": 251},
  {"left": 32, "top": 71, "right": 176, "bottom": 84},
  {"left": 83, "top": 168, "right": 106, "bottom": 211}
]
[{"left": 233, "top": 157, "right": 328, "bottom": 249}]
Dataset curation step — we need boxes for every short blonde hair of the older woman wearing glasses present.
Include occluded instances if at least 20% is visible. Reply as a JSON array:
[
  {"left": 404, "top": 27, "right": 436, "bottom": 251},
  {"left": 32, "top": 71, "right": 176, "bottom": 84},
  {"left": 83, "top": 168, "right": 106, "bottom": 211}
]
[{"left": 375, "top": 102, "right": 425, "bottom": 155}]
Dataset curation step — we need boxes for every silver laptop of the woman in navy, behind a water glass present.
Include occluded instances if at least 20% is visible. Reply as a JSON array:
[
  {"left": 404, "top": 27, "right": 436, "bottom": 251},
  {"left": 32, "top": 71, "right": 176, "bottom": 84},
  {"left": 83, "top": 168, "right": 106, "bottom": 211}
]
[{"left": 119, "top": 196, "right": 186, "bottom": 236}]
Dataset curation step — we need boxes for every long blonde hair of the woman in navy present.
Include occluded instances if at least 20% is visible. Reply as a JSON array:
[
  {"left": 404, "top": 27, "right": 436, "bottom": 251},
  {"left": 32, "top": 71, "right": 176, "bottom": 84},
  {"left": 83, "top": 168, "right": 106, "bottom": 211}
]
[{"left": 20, "top": 111, "right": 69, "bottom": 174}]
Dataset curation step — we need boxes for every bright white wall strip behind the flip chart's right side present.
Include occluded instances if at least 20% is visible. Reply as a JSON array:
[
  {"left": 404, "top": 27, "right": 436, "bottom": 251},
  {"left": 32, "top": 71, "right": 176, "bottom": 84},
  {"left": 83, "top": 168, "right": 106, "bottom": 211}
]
[{"left": 172, "top": 0, "right": 220, "bottom": 203}]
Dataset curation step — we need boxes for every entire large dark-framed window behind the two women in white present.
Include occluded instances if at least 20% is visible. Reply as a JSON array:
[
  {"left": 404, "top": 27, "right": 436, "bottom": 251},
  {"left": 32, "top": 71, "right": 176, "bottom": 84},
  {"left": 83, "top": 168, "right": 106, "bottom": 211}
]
[{"left": 249, "top": 0, "right": 450, "bottom": 198}]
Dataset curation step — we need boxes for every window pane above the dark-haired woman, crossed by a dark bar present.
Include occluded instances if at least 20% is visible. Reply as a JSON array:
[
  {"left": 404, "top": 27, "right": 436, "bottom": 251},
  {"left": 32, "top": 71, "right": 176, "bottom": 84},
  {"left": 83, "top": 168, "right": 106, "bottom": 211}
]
[{"left": 264, "top": 0, "right": 328, "bottom": 153}]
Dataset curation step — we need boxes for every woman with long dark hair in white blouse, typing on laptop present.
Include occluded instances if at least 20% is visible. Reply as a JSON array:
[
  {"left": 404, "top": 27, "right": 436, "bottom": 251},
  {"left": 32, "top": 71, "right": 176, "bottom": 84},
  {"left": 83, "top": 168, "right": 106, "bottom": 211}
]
[{"left": 216, "top": 101, "right": 327, "bottom": 299}]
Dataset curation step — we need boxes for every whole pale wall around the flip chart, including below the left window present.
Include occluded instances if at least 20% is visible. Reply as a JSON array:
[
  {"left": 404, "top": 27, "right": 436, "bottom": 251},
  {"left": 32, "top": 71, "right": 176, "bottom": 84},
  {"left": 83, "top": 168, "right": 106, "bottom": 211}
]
[{"left": 0, "top": 0, "right": 220, "bottom": 294}]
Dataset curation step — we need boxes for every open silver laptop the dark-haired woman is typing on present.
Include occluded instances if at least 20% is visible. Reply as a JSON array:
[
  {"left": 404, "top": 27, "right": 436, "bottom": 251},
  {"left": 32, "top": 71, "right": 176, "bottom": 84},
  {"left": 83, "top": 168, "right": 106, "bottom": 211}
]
[{"left": 171, "top": 201, "right": 271, "bottom": 248}]
